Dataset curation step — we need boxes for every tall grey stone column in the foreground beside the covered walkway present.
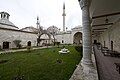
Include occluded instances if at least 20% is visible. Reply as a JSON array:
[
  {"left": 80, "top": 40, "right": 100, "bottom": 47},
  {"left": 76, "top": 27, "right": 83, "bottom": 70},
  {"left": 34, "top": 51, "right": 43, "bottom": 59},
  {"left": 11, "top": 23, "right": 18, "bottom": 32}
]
[{"left": 78, "top": 0, "right": 92, "bottom": 66}]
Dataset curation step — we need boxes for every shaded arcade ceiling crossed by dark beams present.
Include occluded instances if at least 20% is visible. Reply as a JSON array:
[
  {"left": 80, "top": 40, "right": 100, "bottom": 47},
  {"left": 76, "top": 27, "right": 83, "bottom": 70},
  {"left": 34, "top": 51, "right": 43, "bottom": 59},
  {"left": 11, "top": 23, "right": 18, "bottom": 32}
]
[{"left": 90, "top": 0, "right": 120, "bottom": 34}]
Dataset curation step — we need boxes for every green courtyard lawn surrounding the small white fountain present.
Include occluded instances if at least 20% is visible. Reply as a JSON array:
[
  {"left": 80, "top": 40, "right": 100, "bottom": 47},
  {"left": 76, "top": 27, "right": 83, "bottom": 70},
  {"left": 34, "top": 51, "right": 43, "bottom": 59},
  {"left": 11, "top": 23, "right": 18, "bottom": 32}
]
[{"left": 0, "top": 46, "right": 81, "bottom": 80}]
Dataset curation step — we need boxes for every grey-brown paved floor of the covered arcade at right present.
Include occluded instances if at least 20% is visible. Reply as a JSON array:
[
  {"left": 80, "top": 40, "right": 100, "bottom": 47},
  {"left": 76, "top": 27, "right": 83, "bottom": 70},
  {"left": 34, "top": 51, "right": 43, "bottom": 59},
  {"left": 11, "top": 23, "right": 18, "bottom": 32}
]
[{"left": 94, "top": 45, "right": 120, "bottom": 80}]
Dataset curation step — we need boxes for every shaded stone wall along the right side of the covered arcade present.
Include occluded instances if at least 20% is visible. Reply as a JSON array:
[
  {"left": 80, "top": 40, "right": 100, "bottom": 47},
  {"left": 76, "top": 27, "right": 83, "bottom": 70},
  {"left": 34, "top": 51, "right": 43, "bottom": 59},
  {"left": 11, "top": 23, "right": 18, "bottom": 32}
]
[{"left": 99, "top": 20, "right": 120, "bottom": 52}]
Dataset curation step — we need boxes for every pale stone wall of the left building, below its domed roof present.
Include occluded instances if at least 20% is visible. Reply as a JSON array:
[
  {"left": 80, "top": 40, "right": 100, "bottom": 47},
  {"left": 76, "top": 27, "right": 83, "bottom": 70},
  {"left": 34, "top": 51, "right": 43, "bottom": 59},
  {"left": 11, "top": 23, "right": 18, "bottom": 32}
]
[{"left": 0, "top": 29, "right": 37, "bottom": 48}]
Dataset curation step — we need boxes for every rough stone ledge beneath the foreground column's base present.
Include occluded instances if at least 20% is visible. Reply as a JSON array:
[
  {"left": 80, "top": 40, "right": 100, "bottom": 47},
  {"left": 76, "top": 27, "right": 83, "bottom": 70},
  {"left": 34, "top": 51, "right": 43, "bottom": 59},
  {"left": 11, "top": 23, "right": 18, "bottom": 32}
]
[{"left": 69, "top": 54, "right": 98, "bottom": 80}]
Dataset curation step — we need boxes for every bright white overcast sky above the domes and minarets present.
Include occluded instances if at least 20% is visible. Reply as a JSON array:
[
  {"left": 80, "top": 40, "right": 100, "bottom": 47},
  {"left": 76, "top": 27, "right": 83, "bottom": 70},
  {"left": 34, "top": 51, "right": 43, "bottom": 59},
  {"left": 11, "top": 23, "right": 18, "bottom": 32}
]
[{"left": 0, "top": 0, "right": 82, "bottom": 30}]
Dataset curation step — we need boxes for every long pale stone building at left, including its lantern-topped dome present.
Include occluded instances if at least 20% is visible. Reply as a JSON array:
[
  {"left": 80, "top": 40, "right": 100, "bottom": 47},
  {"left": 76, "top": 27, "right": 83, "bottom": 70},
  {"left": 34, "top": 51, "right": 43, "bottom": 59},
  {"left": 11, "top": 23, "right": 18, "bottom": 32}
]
[{"left": 0, "top": 12, "right": 37, "bottom": 49}]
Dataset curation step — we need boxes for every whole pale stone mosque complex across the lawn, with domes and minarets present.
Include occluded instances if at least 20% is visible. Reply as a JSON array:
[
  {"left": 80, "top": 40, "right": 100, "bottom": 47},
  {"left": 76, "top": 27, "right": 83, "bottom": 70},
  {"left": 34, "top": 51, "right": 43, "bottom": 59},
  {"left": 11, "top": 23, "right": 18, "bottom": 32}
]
[{"left": 0, "top": 4, "right": 82, "bottom": 49}]
